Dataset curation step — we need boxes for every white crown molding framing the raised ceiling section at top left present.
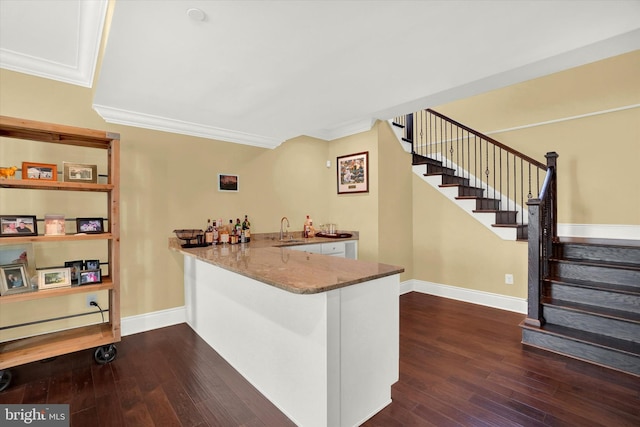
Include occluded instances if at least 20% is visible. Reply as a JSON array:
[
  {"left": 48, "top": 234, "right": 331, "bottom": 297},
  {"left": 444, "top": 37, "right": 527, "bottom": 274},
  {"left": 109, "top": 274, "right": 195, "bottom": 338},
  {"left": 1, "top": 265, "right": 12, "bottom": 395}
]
[{"left": 0, "top": 0, "right": 108, "bottom": 87}]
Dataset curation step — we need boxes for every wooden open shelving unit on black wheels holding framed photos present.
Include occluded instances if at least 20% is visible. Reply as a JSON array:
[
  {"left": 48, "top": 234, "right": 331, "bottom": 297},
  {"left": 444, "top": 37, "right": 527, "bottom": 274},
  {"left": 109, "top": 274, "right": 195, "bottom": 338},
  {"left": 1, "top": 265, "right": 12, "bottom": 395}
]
[{"left": 0, "top": 116, "right": 120, "bottom": 380}]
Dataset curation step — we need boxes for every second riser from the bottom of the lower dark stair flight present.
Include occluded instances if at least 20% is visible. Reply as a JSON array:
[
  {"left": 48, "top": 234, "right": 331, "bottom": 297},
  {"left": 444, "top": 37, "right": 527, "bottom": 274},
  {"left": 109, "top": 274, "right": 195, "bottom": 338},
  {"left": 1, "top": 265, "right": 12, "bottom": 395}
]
[{"left": 543, "top": 305, "right": 640, "bottom": 342}]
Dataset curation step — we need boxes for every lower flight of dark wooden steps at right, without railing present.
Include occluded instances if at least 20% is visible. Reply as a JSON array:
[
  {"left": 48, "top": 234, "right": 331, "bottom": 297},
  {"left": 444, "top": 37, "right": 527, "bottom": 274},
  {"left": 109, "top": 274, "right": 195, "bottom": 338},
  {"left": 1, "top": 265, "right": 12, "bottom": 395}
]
[{"left": 521, "top": 239, "right": 640, "bottom": 376}]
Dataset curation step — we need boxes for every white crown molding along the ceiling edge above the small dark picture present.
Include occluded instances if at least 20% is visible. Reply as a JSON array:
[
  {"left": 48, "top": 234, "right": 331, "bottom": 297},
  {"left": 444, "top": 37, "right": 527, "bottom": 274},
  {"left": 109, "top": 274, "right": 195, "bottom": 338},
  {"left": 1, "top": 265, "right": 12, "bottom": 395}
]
[{"left": 93, "top": 104, "right": 283, "bottom": 149}]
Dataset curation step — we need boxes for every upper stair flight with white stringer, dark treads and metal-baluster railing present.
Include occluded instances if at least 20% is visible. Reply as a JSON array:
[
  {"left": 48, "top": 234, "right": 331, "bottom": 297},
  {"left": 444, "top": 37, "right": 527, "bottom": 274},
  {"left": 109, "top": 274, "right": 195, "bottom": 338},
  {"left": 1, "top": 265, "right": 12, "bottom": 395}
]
[{"left": 391, "top": 109, "right": 547, "bottom": 241}]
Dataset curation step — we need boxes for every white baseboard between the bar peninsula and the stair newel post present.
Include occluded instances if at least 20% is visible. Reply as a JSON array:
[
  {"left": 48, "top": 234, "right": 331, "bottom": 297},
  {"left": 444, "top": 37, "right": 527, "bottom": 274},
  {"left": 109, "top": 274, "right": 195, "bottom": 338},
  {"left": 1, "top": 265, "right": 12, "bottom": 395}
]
[{"left": 400, "top": 279, "right": 527, "bottom": 314}]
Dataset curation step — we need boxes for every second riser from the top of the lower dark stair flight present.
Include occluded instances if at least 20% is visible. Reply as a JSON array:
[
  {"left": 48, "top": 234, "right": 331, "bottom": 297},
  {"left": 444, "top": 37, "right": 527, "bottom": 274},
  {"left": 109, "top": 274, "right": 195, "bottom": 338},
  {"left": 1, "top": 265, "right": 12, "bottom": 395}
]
[{"left": 551, "top": 261, "right": 640, "bottom": 290}]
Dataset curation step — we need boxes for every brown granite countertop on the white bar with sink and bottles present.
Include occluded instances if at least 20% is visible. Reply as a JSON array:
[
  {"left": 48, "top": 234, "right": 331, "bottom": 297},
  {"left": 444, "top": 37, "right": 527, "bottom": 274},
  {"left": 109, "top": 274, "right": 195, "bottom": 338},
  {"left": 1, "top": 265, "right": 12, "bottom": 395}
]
[{"left": 169, "top": 233, "right": 404, "bottom": 294}]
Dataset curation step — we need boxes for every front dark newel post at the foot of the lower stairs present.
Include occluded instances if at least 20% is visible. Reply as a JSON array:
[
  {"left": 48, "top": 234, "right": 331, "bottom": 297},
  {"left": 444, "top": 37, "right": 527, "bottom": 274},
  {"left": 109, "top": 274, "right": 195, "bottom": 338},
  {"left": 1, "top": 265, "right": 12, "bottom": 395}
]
[{"left": 524, "top": 199, "right": 544, "bottom": 327}]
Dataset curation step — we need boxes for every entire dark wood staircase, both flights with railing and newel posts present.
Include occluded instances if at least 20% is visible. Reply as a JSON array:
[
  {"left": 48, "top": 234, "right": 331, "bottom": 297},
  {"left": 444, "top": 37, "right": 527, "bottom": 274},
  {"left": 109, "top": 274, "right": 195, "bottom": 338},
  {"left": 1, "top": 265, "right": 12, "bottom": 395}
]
[{"left": 392, "top": 110, "right": 640, "bottom": 376}]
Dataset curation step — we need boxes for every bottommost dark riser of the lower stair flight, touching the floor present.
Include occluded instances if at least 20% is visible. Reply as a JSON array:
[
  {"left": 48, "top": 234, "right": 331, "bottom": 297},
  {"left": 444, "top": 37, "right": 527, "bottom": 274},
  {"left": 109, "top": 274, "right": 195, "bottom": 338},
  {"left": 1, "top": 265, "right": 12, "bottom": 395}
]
[{"left": 522, "top": 329, "right": 640, "bottom": 375}]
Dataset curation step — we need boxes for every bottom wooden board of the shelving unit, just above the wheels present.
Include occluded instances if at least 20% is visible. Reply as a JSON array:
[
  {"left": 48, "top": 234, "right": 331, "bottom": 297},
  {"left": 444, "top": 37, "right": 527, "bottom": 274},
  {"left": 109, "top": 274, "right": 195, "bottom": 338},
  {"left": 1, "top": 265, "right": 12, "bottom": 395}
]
[{"left": 0, "top": 323, "right": 120, "bottom": 369}]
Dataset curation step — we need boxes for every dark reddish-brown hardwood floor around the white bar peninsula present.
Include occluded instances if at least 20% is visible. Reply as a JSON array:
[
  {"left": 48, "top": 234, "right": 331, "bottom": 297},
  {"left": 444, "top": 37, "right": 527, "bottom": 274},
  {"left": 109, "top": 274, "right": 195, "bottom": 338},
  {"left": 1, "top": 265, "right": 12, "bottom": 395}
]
[{"left": 0, "top": 292, "right": 640, "bottom": 427}]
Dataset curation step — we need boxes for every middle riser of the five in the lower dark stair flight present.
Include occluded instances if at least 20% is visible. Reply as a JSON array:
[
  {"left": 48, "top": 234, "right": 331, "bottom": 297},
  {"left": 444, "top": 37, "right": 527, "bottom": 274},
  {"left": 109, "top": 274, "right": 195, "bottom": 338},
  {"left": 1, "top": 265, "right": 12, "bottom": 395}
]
[{"left": 549, "top": 283, "right": 640, "bottom": 314}]
